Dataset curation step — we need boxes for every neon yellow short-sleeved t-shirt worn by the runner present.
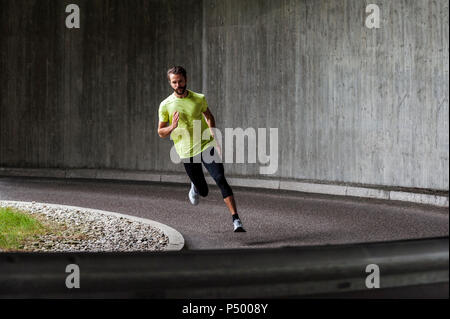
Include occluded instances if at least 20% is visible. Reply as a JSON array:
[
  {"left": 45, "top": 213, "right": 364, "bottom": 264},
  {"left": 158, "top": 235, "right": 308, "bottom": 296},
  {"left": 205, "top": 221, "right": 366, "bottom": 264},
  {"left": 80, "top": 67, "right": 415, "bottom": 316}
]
[{"left": 158, "top": 90, "right": 216, "bottom": 158}]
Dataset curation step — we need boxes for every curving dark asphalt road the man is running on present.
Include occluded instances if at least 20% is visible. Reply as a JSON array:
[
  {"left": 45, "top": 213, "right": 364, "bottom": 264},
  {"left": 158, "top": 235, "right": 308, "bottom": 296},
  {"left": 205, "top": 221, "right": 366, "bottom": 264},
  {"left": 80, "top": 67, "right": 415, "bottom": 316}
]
[{"left": 0, "top": 177, "right": 449, "bottom": 249}]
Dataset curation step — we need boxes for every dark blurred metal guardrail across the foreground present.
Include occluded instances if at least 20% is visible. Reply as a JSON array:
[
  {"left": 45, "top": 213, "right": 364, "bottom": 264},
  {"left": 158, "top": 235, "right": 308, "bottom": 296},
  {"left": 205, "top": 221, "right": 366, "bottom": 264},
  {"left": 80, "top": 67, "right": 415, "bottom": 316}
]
[{"left": 0, "top": 237, "right": 449, "bottom": 298}]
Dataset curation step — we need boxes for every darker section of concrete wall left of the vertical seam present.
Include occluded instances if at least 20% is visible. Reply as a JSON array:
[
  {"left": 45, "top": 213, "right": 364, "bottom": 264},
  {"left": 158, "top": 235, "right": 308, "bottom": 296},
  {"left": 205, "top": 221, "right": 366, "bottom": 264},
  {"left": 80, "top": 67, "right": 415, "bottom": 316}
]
[{"left": 0, "top": 0, "right": 202, "bottom": 170}]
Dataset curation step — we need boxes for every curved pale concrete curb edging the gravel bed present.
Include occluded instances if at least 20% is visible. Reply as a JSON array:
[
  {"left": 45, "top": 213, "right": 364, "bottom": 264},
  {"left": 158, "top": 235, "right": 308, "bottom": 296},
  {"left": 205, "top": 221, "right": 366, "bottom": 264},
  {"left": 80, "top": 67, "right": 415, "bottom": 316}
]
[{"left": 0, "top": 200, "right": 184, "bottom": 251}]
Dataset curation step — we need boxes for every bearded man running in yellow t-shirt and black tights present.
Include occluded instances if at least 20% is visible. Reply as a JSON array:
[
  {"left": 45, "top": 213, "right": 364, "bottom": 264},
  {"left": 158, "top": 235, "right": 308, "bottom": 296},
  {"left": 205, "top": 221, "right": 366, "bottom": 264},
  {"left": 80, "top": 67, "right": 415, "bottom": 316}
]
[{"left": 158, "top": 66, "right": 245, "bottom": 232}]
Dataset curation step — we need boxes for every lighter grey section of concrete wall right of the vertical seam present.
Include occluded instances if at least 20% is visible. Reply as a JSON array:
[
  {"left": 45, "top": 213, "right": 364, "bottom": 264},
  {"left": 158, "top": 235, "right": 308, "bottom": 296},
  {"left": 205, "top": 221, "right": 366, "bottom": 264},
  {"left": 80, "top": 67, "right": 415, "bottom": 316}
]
[{"left": 203, "top": 0, "right": 449, "bottom": 189}]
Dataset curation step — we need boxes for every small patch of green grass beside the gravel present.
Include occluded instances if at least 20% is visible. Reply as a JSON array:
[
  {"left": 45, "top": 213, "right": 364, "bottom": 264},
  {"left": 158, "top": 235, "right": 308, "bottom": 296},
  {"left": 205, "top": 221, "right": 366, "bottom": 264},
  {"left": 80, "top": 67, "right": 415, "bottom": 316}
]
[{"left": 0, "top": 207, "right": 47, "bottom": 251}]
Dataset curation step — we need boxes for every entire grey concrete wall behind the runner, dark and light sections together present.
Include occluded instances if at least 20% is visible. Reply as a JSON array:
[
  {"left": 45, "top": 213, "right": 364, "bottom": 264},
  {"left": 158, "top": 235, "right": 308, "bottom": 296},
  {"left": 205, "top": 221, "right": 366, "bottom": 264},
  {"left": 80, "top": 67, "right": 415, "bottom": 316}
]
[{"left": 0, "top": 0, "right": 449, "bottom": 190}]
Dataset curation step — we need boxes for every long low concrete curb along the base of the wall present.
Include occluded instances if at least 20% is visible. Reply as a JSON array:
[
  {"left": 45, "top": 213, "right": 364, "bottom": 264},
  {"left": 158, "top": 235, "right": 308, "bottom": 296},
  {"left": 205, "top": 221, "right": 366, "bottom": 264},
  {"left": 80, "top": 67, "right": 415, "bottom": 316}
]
[{"left": 0, "top": 167, "right": 449, "bottom": 207}]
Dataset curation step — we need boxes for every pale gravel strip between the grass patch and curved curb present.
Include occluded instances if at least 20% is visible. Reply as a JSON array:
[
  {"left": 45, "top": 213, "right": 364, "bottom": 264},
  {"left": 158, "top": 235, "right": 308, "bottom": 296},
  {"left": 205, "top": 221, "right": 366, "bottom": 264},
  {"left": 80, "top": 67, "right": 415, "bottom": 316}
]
[{"left": 0, "top": 201, "right": 169, "bottom": 252}]
